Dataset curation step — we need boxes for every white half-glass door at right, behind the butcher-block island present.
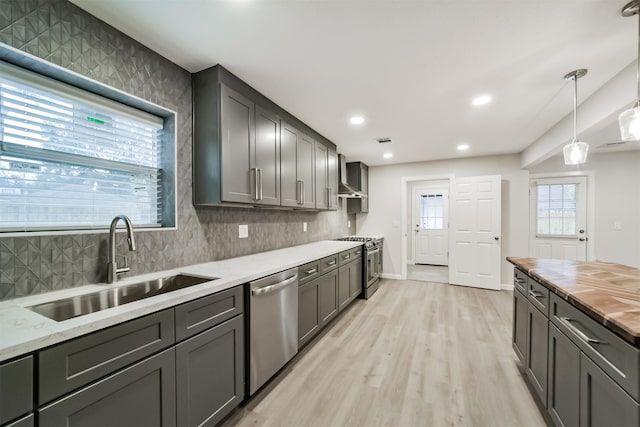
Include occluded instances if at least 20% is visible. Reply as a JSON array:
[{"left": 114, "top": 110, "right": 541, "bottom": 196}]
[{"left": 529, "top": 176, "right": 587, "bottom": 261}]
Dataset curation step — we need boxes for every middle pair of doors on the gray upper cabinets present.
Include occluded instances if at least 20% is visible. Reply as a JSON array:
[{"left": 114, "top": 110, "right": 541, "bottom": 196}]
[{"left": 280, "top": 121, "right": 316, "bottom": 209}]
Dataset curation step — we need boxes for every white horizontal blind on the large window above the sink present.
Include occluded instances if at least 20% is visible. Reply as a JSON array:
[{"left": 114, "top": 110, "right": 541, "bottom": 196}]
[{"left": 0, "top": 63, "right": 163, "bottom": 231}]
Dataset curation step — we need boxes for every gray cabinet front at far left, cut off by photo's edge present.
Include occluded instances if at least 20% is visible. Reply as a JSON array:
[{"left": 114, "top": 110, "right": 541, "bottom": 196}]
[{"left": 0, "top": 356, "right": 33, "bottom": 424}]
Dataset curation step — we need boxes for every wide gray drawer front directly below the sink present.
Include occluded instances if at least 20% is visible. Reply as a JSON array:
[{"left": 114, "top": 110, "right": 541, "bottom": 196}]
[{"left": 38, "top": 308, "right": 175, "bottom": 404}]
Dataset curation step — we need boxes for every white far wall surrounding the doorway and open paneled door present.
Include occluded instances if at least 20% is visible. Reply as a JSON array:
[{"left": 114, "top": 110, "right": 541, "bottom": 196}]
[{"left": 356, "top": 155, "right": 529, "bottom": 284}]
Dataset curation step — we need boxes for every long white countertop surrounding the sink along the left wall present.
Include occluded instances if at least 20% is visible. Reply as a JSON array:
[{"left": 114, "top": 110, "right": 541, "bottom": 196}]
[{"left": 0, "top": 240, "right": 361, "bottom": 361}]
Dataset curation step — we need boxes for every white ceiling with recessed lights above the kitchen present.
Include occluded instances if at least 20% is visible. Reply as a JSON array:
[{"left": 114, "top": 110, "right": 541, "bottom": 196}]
[{"left": 72, "top": 0, "right": 638, "bottom": 165}]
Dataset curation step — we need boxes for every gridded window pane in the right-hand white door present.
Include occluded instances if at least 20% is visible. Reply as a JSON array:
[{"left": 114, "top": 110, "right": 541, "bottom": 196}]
[{"left": 536, "top": 184, "right": 578, "bottom": 236}]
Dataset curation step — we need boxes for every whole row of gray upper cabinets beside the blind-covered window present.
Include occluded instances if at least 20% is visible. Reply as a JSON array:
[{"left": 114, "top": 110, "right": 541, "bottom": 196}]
[{"left": 193, "top": 66, "right": 337, "bottom": 209}]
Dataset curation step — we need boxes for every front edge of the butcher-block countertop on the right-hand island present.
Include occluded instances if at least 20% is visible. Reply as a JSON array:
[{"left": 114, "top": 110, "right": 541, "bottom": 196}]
[{"left": 506, "top": 257, "right": 640, "bottom": 348}]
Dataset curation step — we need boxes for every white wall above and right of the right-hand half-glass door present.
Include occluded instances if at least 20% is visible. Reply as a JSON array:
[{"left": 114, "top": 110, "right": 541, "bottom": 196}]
[{"left": 530, "top": 151, "right": 640, "bottom": 268}]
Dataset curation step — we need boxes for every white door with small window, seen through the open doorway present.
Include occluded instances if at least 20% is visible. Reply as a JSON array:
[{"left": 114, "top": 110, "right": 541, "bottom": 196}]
[{"left": 413, "top": 188, "right": 449, "bottom": 265}]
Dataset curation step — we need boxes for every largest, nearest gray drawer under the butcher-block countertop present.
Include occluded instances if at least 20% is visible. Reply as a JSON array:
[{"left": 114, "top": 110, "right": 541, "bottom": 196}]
[{"left": 550, "top": 294, "right": 640, "bottom": 400}]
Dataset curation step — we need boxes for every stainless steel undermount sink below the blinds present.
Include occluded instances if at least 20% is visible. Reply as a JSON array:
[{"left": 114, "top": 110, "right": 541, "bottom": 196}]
[{"left": 25, "top": 274, "right": 217, "bottom": 322}]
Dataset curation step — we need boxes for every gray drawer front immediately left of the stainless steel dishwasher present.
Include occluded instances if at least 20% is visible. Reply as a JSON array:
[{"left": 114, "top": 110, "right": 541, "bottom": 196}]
[{"left": 175, "top": 286, "right": 243, "bottom": 341}]
